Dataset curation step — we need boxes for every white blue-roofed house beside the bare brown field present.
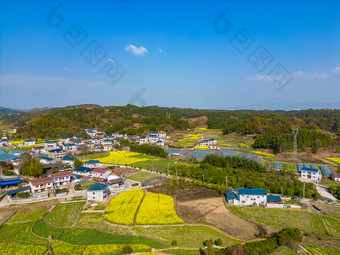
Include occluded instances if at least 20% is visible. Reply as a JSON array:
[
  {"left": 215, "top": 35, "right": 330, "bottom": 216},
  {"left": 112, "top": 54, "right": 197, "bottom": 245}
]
[{"left": 225, "top": 189, "right": 267, "bottom": 206}]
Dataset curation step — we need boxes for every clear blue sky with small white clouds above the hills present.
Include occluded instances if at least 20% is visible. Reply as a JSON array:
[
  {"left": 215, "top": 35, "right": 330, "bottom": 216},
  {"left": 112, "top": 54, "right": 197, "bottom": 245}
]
[{"left": 0, "top": 0, "right": 340, "bottom": 109}]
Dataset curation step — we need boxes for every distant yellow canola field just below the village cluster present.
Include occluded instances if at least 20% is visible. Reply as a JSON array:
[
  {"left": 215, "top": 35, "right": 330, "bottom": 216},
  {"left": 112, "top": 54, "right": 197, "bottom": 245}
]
[{"left": 91, "top": 151, "right": 150, "bottom": 165}]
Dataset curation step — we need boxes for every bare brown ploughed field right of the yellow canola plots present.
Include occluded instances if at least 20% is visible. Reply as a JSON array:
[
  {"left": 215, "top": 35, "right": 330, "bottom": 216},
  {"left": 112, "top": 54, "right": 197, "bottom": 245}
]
[{"left": 176, "top": 196, "right": 279, "bottom": 240}]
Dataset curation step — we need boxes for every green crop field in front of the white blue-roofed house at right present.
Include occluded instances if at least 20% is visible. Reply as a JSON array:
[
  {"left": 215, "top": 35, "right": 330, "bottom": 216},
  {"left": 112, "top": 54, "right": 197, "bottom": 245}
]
[{"left": 229, "top": 206, "right": 340, "bottom": 238}]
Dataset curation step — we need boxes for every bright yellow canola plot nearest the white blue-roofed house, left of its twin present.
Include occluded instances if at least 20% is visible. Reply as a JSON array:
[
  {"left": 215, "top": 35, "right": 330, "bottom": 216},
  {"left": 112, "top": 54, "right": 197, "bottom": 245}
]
[{"left": 104, "top": 189, "right": 144, "bottom": 225}]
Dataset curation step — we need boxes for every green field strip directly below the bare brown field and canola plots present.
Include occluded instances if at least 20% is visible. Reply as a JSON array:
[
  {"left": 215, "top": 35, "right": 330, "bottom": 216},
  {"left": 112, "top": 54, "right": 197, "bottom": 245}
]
[{"left": 133, "top": 226, "right": 238, "bottom": 247}]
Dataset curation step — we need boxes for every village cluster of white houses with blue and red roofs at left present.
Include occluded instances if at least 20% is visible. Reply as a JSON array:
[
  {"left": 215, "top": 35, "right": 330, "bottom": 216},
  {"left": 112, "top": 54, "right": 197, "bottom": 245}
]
[{"left": 0, "top": 129, "right": 169, "bottom": 201}]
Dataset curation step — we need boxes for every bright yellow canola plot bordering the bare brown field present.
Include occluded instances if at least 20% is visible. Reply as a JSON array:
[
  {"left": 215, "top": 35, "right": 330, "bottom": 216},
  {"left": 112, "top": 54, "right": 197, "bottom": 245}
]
[{"left": 136, "top": 192, "right": 184, "bottom": 225}]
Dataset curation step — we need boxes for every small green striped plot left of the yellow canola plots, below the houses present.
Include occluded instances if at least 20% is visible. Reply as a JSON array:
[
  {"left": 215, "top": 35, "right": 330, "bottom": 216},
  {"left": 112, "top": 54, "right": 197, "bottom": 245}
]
[{"left": 45, "top": 201, "right": 85, "bottom": 227}]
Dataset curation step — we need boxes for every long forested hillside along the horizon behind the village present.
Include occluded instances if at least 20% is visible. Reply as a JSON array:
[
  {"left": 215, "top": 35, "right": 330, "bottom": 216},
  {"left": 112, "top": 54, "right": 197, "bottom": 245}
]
[{"left": 1, "top": 105, "right": 340, "bottom": 153}]
